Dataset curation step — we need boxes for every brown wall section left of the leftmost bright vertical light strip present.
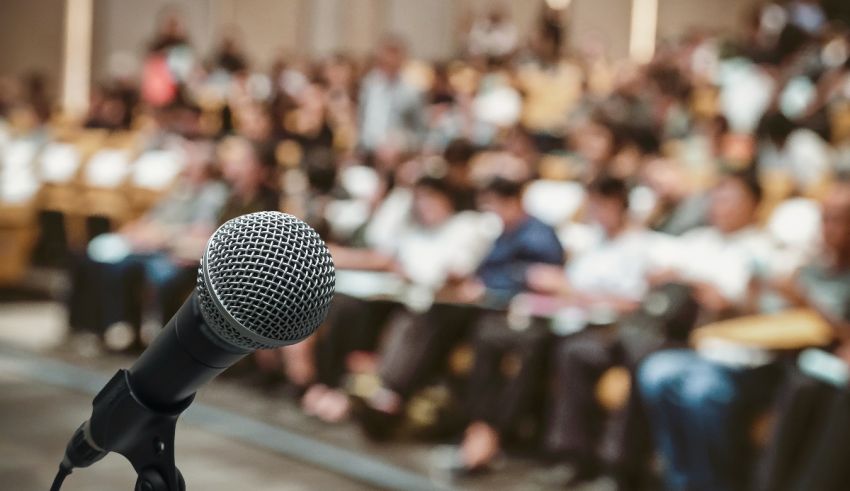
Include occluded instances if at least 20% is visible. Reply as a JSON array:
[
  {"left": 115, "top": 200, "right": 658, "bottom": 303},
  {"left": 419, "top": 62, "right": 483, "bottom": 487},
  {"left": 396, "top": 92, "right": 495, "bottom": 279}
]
[{"left": 0, "top": 0, "right": 65, "bottom": 83}]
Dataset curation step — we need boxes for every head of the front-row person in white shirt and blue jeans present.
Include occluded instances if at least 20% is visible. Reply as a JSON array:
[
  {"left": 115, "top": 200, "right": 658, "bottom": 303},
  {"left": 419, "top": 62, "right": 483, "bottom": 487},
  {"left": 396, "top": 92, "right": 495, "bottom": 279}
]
[{"left": 709, "top": 171, "right": 762, "bottom": 234}]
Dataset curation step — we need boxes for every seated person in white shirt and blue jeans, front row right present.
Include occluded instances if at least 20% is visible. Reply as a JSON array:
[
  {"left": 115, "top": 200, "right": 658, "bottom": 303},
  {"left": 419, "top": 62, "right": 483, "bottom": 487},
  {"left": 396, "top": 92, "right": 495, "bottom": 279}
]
[{"left": 637, "top": 171, "right": 796, "bottom": 490}]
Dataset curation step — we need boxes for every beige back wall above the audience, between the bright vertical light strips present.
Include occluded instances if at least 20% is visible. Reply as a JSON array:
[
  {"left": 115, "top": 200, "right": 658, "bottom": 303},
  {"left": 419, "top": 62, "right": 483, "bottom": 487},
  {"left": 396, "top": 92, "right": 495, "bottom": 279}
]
[{"left": 0, "top": 0, "right": 758, "bottom": 101}]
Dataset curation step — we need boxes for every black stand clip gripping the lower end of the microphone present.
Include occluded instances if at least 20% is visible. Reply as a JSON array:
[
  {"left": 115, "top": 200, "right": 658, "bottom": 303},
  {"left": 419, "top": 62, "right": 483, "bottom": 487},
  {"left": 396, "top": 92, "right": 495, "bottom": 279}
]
[{"left": 69, "top": 369, "right": 194, "bottom": 491}]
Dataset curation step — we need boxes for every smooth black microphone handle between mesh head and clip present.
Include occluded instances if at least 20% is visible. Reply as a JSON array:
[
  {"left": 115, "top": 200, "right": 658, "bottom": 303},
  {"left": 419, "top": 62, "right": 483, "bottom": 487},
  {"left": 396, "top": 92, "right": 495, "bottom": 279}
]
[{"left": 128, "top": 291, "right": 248, "bottom": 410}]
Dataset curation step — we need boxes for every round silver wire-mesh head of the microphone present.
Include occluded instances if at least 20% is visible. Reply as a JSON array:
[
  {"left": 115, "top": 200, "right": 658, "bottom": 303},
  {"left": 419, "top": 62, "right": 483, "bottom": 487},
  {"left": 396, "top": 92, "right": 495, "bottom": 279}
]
[{"left": 197, "top": 211, "right": 335, "bottom": 351}]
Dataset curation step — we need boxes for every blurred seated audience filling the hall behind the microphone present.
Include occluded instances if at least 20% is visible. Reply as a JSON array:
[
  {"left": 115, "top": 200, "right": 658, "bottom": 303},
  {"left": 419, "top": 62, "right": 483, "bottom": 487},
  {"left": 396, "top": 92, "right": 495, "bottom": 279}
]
[{"left": 0, "top": 0, "right": 850, "bottom": 490}]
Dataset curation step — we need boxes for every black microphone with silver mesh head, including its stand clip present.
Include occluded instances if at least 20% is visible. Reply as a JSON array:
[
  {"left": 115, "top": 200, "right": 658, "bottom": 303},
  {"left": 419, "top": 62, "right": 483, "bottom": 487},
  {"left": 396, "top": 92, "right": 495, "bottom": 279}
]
[{"left": 52, "top": 212, "right": 335, "bottom": 490}]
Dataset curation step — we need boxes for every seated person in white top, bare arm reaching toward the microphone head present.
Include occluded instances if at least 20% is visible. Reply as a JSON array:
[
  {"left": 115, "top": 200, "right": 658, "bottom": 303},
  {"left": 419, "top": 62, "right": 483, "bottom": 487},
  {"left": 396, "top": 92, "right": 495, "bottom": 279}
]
[{"left": 303, "top": 177, "right": 489, "bottom": 421}]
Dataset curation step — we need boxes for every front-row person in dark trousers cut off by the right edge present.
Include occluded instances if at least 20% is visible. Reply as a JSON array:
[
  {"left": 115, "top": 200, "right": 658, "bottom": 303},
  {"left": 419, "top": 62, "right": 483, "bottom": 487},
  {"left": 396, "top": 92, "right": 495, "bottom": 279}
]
[{"left": 754, "top": 182, "right": 850, "bottom": 491}]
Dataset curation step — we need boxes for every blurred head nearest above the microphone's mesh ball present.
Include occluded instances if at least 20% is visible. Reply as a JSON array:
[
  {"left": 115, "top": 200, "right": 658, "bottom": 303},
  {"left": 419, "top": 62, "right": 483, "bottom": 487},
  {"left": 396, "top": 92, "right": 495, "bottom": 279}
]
[{"left": 221, "top": 137, "right": 277, "bottom": 198}]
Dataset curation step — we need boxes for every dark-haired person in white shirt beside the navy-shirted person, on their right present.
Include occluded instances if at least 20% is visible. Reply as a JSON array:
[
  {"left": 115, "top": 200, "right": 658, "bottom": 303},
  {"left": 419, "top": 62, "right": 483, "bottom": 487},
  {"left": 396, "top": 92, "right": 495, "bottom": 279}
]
[{"left": 448, "top": 176, "right": 654, "bottom": 476}]
